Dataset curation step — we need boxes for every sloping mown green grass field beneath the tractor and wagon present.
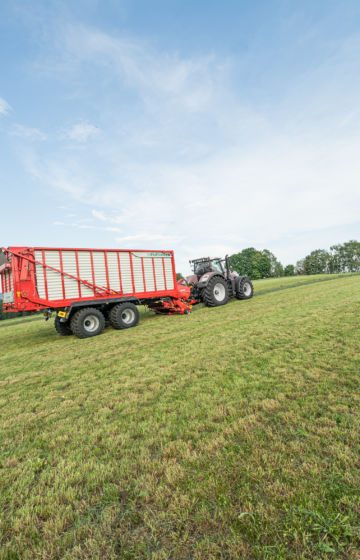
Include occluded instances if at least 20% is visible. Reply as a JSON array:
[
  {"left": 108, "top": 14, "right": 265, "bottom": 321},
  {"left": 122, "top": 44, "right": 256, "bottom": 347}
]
[{"left": 0, "top": 276, "right": 360, "bottom": 560}]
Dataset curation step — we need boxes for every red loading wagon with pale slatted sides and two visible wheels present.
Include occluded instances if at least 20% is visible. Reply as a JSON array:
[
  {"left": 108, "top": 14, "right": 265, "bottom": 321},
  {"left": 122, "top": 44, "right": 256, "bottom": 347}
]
[{"left": 0, "top": 247, "right": 191, "bottom": 338}]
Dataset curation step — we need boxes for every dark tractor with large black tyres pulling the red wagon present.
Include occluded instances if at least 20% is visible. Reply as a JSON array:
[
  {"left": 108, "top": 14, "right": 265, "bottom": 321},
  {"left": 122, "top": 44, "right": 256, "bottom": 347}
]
[{"left": 186, "top": 255, "right": 254, "bottom": 307}]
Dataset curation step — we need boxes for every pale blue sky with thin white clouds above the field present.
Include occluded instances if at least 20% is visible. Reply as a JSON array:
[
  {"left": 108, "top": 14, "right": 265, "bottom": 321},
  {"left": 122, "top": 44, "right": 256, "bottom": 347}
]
[{"left": 0, "top": 0, "right": 360, "bottom": 273}]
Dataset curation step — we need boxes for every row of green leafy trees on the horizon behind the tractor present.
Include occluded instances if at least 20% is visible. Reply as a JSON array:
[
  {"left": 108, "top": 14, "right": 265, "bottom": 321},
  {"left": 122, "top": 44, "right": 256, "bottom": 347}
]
[{"left": 230, "top": 240, "right": 360, "bottom": 280}]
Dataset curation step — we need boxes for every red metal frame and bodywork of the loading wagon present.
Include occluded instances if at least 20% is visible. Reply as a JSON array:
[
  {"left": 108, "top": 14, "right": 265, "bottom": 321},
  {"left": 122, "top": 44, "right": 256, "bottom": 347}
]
[{"left": 0, "top": 247, "right": 190, "bottom": 314}]
